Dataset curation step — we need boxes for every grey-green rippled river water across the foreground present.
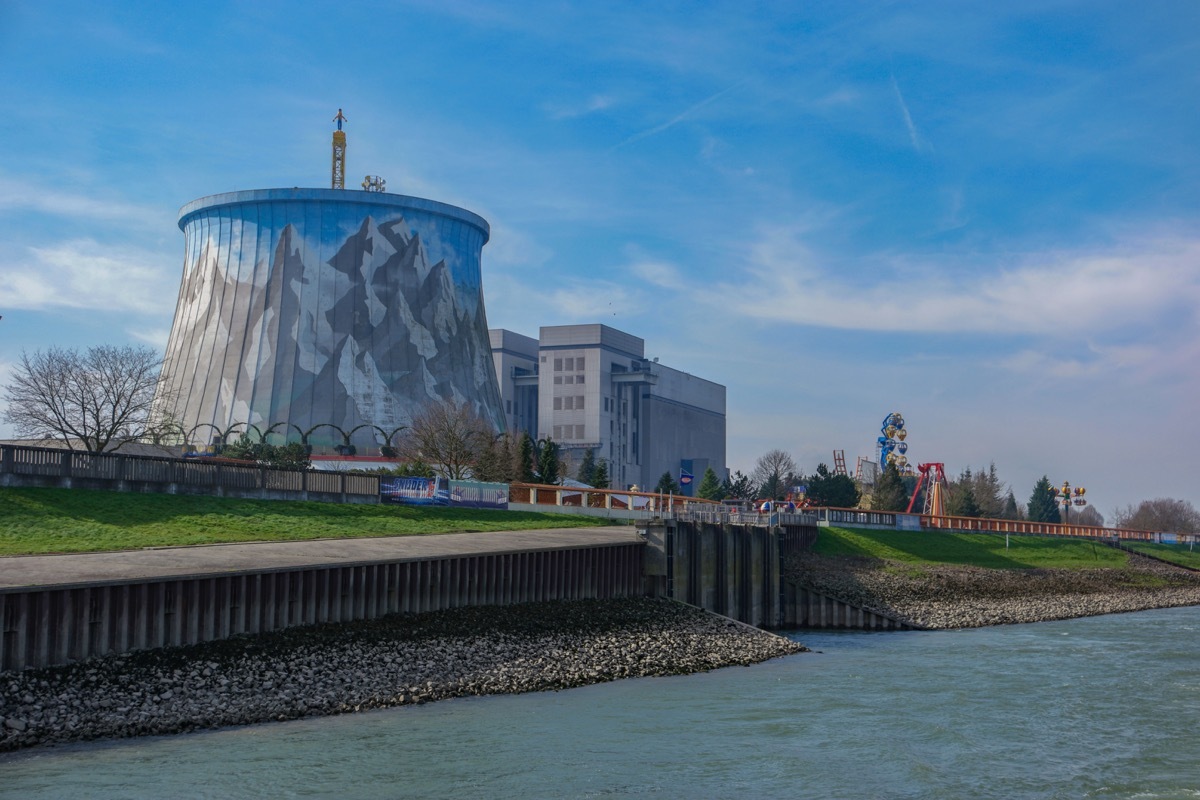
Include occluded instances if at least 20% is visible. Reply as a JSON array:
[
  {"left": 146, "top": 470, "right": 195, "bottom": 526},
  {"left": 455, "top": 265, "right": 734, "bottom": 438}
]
[{"left": 0, "top": 607, "right": 1200, "bottom": 800}]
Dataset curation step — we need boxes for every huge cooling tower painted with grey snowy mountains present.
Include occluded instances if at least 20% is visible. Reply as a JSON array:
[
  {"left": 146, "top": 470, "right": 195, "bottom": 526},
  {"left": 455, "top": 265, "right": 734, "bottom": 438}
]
[{"left": 156, "top": 188, "right": 504, "bottom": 452}]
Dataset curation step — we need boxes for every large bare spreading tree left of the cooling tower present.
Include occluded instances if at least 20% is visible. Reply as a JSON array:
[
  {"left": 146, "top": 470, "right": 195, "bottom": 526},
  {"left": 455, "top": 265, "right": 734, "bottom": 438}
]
[{"left": 5, "top": 344, "right": 162, "bottom": 452}]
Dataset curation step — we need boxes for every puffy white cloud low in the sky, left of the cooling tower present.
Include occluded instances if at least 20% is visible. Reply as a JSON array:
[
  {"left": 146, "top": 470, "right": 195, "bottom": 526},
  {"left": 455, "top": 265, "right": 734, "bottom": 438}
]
[{"left": 0, "top": 239, "right": 178, "bottom": 314}]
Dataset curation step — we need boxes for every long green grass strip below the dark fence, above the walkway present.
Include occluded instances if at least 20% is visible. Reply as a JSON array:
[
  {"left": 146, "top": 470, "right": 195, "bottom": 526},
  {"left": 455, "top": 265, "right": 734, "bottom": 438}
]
[{"left": 0, "top": 488, "right": 613, "bottom": 555}]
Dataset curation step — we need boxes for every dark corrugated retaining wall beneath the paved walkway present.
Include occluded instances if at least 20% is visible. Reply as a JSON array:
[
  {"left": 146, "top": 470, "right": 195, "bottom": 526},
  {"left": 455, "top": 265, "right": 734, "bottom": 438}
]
[{"left": 0, "top": 542, "right": 644, "bottom": 670}]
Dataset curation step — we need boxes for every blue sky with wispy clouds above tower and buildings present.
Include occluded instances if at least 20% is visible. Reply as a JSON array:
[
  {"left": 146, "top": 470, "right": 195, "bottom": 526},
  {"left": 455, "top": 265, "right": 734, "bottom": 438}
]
[{"left": 0, "top": 0, "right": 1200, "bottom": 518}]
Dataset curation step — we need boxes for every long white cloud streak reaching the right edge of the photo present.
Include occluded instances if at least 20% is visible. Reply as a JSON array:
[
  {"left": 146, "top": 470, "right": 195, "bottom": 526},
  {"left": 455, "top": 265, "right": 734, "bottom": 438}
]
[{"left": 715, "top": 229, "right": 1200, "bottom": 335}]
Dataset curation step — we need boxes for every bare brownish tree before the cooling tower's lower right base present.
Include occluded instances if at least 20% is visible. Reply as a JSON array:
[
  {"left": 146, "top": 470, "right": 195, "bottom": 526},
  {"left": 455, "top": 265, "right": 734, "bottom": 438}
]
[{"left": 398, "top": 402, "right": 496, "bottom": 480}]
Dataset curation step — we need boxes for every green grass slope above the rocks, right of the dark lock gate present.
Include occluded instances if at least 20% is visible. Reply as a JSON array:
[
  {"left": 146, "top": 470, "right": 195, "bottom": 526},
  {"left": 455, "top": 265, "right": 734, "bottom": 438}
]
[{"left": 812, "top": 528, "right": 1128, "bottom": 570}]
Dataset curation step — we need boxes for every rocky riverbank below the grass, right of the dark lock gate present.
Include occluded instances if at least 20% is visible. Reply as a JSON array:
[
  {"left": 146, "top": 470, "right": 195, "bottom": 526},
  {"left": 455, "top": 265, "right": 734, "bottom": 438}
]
[{"left": 787, "top": 553, "right": 1200, "bottom": 628}]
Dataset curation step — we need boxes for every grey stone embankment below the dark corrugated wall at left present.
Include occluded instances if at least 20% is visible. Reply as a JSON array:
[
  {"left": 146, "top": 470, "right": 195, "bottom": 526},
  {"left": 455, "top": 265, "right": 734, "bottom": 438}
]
[{"left": 0, "top": 599, "right": 805, "bottom": 752}]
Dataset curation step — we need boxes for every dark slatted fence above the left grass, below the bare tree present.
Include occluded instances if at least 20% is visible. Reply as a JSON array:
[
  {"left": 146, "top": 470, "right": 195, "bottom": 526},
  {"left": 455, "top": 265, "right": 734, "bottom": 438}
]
[{"left": 0, "top": 445, "right": 379, "bottom": 503}]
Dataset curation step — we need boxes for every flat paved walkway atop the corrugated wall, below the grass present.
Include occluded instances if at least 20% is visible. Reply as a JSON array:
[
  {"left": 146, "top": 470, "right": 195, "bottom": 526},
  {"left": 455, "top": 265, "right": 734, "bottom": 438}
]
[{"left": 0, "top": 525, "right": 642, "bottom": 589}]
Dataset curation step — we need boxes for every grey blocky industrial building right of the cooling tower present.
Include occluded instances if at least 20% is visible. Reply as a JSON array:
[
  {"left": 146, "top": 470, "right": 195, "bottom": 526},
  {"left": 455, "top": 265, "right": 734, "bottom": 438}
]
[{"left": 488, "top": 325, "right": 725, "bottom": 494}]
